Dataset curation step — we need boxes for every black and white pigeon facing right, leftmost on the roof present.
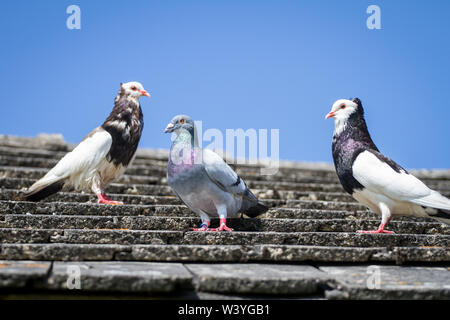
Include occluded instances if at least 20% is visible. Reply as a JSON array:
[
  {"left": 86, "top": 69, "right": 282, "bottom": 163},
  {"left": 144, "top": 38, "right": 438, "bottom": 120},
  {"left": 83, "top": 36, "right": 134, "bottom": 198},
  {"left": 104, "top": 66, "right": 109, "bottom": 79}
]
[{"left": 24, "top": 82, "right": 150, "bottom": 205}]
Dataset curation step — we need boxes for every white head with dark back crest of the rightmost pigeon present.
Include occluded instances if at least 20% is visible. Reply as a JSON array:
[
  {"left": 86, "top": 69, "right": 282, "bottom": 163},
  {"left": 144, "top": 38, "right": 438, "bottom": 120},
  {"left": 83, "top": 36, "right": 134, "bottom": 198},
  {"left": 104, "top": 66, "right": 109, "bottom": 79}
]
[{"left": 325, "top": 98, "right": 364, "bottom": 135}]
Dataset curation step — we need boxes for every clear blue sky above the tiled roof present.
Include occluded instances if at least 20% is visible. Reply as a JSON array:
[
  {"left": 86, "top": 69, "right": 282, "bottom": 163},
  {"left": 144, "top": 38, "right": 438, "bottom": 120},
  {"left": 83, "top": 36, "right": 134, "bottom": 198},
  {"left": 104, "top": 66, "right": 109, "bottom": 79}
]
[{"left": 0, "top": 0, "right": 450, "bottom": 168}]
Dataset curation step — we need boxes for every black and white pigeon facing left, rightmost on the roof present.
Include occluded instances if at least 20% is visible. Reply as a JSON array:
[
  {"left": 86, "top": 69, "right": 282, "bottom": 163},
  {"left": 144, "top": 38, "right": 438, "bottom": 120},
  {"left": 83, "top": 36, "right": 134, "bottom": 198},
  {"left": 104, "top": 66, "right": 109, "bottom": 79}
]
[{"left": 325, "top": 98, "right": 450, "bottom": 233}]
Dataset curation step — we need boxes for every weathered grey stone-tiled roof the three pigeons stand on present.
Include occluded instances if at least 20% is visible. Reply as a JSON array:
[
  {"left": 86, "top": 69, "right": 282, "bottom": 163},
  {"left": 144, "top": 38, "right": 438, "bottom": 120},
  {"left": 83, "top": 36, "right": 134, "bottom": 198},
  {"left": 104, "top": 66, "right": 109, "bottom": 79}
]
[{"left": 0, "top": 135, "right": 450, "bottom": 299}]
